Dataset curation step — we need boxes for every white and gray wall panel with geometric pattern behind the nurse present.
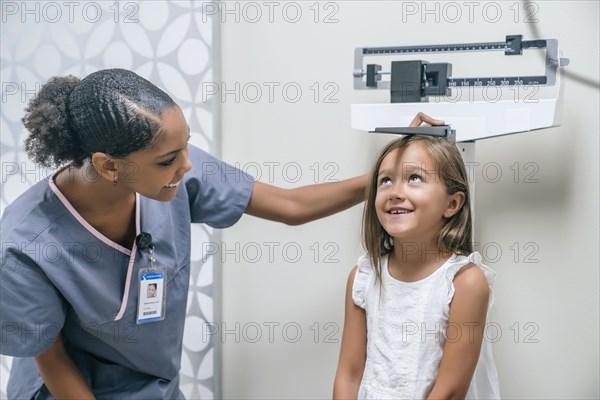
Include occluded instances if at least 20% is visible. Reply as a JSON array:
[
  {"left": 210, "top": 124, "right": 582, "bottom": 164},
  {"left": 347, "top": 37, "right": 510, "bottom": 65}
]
[{"left": 0, "top": 0, "right": 218, "bottom": 399}]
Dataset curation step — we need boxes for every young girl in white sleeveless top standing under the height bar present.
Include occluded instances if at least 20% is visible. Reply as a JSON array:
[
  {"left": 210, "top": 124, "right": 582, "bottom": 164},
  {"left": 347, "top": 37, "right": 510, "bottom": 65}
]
[{"left": 334, "top": 136, "right": 499, "bottom": 399}]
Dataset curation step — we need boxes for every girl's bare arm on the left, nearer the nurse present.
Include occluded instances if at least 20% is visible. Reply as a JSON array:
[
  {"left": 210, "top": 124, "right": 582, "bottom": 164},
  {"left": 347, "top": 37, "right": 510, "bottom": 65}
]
[{"left": 333, "top": 267, "right": 367, "bottom": 399}]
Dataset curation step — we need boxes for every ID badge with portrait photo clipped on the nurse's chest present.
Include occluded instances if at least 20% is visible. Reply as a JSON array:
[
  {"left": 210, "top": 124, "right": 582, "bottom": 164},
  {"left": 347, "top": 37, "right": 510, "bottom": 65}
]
[{"left": 136, "top": 266, "right": 167, "bottom": 325}]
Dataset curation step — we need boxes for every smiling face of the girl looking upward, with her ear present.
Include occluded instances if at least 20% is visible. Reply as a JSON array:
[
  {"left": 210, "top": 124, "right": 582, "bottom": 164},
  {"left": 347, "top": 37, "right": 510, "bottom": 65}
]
[{"left": 375, "top": 143, "right": 464, "bottom": 250}]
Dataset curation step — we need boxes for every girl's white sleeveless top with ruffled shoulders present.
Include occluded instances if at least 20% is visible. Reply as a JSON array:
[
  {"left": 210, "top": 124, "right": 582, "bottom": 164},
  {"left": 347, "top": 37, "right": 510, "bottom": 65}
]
[{"left": 352, "top": 252, "right": 500, "bottom": 399}]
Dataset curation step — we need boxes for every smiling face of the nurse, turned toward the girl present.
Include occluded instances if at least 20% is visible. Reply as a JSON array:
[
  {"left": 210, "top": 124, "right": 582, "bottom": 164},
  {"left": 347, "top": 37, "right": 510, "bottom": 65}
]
[{"left": 118, "top": 107, "right": 192, "bottom": 201}]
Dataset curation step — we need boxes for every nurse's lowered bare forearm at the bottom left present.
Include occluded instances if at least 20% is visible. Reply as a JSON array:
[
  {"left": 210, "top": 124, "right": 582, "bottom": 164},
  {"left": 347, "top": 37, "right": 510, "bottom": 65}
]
[{"left": 35, "top": 335, "right": 94, "bottom": 400}]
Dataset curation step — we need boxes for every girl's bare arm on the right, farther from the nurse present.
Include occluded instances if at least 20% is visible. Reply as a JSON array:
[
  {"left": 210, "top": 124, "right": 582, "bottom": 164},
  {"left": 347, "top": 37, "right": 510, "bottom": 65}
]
[{"left": 428, "top": 265, "right": 489, "bottom": 399}]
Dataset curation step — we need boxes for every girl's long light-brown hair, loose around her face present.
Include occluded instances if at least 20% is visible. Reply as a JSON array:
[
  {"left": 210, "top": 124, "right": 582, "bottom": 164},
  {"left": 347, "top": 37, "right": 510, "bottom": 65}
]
[{"left": 362, "top": 135, "right": 472, "bottom": 282}]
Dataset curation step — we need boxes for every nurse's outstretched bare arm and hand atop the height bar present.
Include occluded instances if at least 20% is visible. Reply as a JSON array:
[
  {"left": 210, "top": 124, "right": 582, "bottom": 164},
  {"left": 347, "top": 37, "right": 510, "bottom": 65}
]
[{"left": 241, "top": 113, "right": 444, "bottom": 225}]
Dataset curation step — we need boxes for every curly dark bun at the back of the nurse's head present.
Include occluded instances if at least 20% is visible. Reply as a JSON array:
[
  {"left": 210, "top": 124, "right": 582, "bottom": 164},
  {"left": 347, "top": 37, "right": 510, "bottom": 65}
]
[{"left": 22, "top": 76, "right": 82, "bottom": 167}]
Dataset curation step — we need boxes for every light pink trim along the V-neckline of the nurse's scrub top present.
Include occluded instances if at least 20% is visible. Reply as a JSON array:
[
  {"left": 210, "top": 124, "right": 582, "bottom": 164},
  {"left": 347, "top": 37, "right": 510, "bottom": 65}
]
[{"left": 48, "top": 176, "right": 141, "bottom": 321}]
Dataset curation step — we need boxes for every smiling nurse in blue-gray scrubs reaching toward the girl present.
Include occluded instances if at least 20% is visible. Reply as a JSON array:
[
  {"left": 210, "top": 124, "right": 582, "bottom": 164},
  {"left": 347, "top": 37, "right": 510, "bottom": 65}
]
[{"left": 0, "top": 69, "right": 439, "bottom": 399}]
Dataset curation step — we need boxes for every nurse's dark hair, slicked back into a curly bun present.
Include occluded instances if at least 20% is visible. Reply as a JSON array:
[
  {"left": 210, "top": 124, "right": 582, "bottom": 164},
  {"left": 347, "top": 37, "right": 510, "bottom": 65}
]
[{"left": 22, "top": 69, "right": 177, "bottom": 167}]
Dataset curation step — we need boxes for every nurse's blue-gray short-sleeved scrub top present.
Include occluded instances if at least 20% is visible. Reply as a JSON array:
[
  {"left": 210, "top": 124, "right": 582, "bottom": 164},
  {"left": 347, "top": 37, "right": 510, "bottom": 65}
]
[{"left": 0, "top": 145, "right": 253, "bottom": 399}]
